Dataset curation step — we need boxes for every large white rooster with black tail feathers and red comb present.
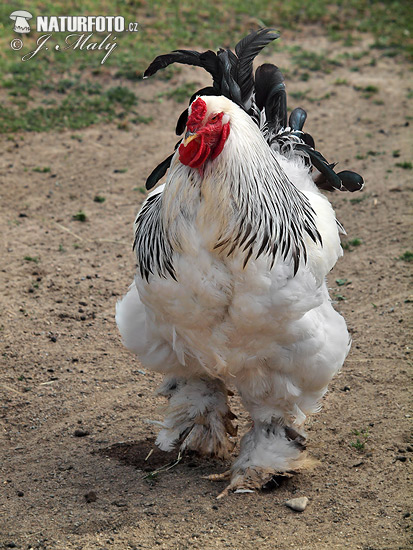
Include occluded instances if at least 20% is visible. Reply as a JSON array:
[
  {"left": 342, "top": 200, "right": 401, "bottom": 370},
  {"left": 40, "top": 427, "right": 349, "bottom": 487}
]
[{"left": 116, "top": 29, "right": 363, "bottom": 495}]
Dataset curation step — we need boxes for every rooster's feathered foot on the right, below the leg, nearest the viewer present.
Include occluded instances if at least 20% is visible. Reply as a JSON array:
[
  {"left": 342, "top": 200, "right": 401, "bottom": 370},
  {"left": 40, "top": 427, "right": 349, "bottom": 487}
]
[{"left": 208, "top": 421, "right": 307, "bottom": 498}]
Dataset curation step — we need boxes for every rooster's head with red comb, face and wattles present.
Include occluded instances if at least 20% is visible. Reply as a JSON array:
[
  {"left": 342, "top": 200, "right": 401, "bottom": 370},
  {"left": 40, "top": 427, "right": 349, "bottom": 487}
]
[{"left": 179, "top": 96, "right": 230, "bottom": 168}]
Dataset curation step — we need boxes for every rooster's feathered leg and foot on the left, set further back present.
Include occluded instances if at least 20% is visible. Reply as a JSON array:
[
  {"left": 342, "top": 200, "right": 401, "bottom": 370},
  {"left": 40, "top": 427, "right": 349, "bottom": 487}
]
[{"left": 156, "top": 379, "right": 237, "bottom": 459}]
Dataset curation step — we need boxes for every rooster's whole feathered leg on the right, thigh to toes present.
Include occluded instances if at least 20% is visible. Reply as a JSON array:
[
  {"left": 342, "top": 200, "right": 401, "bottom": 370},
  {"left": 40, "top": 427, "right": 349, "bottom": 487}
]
[{"left": 210, "top": 370, "right": 325, "bottom": 497}]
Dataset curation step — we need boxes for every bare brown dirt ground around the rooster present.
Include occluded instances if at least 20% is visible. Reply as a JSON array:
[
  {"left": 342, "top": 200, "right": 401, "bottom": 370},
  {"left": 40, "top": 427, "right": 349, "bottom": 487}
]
[{"left": 0, "top": 32, "right": 413, "bottom": 550}]
